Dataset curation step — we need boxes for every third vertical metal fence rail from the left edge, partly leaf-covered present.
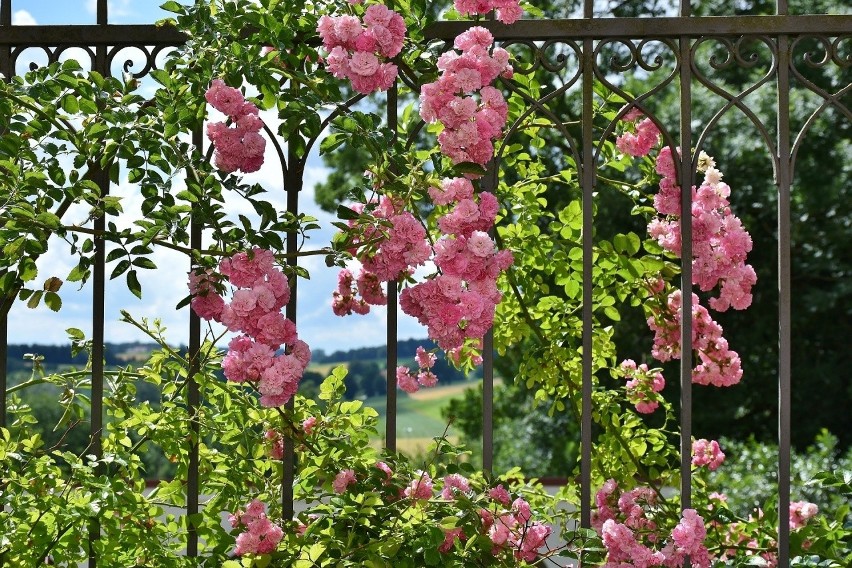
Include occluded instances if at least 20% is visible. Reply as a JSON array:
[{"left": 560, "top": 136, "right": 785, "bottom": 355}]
[{"left": 186, "top": 127, "right": 204, "bottom": 558}]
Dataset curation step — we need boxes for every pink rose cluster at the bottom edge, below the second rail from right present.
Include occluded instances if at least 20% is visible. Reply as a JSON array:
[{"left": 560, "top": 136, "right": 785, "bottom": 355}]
[{"left": 592, "top": 479, "right": 711, "bottom": 568}]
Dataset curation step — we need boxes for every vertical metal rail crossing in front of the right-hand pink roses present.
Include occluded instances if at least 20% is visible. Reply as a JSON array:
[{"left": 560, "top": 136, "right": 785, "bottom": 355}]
[{"left": 675, "top": 0, "right": 694, "bottom": 532}]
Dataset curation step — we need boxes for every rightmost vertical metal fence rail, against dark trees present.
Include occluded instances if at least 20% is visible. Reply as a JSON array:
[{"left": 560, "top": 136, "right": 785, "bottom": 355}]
[{"left": 775, "top": 0, "right": 792, "bottom": 567}]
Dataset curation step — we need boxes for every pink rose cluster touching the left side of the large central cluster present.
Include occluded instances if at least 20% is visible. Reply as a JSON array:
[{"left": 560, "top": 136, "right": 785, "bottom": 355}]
[{"left": 332, "top": 196, "right": 432, "bottom": 316}]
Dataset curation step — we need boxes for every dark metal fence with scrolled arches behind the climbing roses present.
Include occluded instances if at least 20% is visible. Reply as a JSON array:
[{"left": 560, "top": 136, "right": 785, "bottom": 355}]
[{"left": 0, "top": 0, "right": 852, "bottom": 566}]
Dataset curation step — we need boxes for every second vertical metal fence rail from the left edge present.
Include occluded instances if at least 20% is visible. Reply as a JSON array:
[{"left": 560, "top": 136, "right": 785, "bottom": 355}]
[{"left": 88, "top": 0, "right": 109, "bottom": 568}]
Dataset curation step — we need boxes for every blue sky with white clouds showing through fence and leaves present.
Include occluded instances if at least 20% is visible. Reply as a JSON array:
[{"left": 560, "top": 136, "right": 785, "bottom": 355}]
[{"left": 9, "top": 0, "right": 426, "bottom": 351}]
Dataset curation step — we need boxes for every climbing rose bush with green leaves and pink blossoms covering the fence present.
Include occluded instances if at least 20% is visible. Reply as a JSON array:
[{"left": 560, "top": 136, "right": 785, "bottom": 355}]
[{"left": 0, "top": 0, "right": 850, "bottom": 567}]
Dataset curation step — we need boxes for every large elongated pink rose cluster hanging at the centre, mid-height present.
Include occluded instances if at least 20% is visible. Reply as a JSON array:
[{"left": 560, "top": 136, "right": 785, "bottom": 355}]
[{"left": 399, "top": 178, "right": 513, "bottom": 351}]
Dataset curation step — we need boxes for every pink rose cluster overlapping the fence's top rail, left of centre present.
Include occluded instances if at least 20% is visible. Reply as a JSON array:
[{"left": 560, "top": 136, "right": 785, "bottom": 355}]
[{"left": 317, "top": 4, "right": 405, "bottom": 94}]
